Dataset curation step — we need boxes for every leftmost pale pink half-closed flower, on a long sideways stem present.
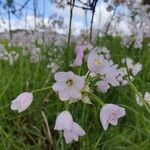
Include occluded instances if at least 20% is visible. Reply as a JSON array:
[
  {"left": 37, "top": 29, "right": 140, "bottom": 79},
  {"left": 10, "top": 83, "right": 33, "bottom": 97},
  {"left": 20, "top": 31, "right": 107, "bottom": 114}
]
[{"left": 11, "top": 92, "right": 33, "bottom": 113}]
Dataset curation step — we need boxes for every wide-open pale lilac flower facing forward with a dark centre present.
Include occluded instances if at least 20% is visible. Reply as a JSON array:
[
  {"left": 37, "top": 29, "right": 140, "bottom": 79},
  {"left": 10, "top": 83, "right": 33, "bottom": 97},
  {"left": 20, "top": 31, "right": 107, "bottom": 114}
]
[{"left": 52, "top": 71, "right": 85, "bottom": 101}]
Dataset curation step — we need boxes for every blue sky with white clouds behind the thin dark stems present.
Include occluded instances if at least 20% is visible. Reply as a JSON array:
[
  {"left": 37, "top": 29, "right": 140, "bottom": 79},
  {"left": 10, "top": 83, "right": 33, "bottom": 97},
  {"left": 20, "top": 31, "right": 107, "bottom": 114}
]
[{"left": 0, "top": 0, "right": 131, "bottom": 35}]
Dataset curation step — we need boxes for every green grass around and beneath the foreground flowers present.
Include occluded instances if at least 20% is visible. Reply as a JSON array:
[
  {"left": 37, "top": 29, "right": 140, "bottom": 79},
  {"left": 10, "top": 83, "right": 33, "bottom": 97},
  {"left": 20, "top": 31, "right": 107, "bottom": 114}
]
[{"left": 0, "top": 37, "right": 150, "bottom": 150}]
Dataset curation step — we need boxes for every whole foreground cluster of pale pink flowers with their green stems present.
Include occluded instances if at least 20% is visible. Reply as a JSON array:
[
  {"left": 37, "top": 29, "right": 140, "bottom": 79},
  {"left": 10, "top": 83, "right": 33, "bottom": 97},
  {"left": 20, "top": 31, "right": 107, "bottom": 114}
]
[{"left": 8, "top": 45, "right": 145, "bottom": 144}]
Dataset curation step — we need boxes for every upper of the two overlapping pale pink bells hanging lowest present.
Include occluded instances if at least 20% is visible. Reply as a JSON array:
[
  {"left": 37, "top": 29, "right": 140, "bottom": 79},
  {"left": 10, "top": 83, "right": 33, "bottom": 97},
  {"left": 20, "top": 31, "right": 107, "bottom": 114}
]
[{"left": 54, "top": 111, "right": 73, "bottom": 131}]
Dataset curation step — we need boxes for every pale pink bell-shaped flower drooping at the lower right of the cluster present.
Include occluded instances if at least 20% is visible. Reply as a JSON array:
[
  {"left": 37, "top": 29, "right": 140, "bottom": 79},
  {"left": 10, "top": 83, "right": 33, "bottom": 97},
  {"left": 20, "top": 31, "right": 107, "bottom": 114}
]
[{"left": 100, "top": 104, "right": 126, "bottom": 130}]
